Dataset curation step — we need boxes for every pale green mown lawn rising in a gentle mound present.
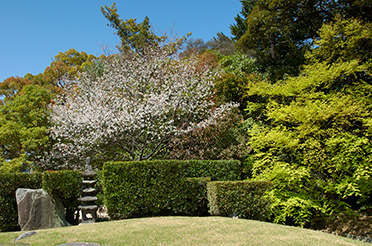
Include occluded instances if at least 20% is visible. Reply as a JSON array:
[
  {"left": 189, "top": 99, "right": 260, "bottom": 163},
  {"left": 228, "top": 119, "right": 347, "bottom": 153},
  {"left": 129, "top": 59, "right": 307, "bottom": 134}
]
[{"left": 0, "top": 217, "right": 371, "bottom": 246}]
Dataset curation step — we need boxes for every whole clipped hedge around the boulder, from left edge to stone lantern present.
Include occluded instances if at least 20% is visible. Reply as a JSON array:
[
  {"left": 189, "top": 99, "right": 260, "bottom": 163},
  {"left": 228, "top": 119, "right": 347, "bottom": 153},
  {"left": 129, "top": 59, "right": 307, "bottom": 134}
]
[{"left": 0, "top": 171, "right": 81, "bottom": 231}]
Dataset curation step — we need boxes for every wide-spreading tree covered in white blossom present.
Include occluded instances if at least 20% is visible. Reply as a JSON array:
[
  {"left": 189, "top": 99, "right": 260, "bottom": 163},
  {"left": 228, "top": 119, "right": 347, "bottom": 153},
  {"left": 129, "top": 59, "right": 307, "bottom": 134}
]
[{"left": 46, "top": 45, "right": 237, "bottom": 168}]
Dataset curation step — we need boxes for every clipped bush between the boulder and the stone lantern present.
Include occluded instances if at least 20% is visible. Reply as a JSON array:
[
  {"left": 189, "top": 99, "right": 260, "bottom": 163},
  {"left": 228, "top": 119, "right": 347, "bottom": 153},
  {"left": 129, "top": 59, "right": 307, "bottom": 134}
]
[{"left": 42, "top": 170, "right": 82, "bottom": 224}]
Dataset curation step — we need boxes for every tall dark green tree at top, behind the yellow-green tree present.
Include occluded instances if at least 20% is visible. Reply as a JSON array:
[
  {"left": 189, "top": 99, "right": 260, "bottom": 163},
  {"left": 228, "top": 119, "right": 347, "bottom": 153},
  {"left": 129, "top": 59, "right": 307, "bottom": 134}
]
[{"left": 232, "top": 0, "right": 324, "bottom": 81}]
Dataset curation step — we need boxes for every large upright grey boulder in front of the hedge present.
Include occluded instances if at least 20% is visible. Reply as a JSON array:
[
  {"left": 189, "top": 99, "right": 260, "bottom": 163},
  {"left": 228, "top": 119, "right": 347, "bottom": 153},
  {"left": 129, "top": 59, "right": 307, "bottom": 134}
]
[{"left": 16, "top": 188, "right": 69, "bottom": 231}]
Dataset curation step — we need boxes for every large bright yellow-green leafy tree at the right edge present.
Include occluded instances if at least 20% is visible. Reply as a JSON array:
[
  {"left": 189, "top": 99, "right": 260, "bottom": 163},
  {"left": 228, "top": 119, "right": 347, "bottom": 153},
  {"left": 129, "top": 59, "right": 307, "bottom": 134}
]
[{"left": 247, "top": 18, "right": 372, "bottom": 226}]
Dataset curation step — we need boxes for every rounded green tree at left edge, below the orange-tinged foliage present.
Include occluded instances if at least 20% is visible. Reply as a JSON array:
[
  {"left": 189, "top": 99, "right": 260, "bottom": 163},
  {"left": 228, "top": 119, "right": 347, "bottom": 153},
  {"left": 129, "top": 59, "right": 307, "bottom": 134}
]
[{"left": 0, "top": 85, "right": 51, "bottom": 171}]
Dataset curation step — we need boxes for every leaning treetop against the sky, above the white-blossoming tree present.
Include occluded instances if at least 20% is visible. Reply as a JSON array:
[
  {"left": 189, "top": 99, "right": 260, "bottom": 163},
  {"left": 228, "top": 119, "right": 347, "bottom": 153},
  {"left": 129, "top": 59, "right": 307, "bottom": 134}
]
[{"left": 101, "top": 3, "right": 166, "bottom": 53}]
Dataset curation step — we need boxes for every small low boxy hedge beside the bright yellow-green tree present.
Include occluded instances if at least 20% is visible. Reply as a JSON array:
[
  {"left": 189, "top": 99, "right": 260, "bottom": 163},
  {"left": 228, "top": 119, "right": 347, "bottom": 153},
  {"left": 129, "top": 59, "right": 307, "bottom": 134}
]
[{"left": 207, "top": 181, "right": 272, "bottom": 220}]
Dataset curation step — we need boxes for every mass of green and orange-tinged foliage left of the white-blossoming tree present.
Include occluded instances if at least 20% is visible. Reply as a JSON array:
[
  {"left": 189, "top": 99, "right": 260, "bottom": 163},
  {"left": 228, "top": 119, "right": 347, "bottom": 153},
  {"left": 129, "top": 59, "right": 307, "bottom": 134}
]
[{"left": 0, "top": 49, "right": 96, "bottom": 172}]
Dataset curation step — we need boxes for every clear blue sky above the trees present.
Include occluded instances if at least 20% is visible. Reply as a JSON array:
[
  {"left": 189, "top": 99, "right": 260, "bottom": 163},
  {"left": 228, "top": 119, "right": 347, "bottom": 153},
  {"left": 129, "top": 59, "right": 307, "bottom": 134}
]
[{"left": 0, "top": 0, "right": 241, "bottom": 82}]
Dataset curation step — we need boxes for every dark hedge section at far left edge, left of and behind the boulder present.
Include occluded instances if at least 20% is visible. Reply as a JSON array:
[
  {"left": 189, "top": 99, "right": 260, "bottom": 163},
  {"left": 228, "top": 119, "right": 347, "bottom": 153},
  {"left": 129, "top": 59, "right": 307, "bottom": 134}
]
[{"left": 0, "top": 173, "right": 42, "bottom": 231}]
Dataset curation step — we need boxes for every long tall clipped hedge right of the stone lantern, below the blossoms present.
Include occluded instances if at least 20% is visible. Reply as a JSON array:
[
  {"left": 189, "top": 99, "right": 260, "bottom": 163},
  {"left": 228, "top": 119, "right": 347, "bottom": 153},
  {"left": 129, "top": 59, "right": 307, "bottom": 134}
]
[{"left": 103, "top": 160, "right": 240, "bottom": 219}]
